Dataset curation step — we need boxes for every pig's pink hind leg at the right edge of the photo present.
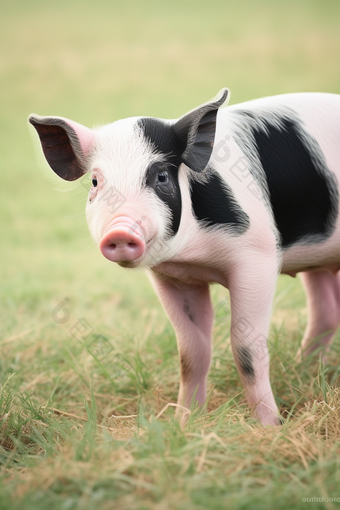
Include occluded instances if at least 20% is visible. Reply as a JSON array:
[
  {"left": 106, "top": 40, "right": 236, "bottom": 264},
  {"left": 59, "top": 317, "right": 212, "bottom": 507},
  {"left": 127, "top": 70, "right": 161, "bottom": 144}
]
[{"left": 297, "top": 271, "right": 340, "bottom": 359}]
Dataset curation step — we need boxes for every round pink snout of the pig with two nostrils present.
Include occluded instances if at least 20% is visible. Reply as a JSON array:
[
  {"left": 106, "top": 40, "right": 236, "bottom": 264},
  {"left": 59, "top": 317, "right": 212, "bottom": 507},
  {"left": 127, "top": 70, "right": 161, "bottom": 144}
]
[{"left": 99, "top": 217, "right": 145, "bottom": 262}]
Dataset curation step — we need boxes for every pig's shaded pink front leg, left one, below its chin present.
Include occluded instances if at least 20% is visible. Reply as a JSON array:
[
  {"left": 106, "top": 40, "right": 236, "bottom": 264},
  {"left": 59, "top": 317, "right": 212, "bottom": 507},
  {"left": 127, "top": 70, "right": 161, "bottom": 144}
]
[{"left": 150, "top": 273, "right": 214, "bottom": 409}]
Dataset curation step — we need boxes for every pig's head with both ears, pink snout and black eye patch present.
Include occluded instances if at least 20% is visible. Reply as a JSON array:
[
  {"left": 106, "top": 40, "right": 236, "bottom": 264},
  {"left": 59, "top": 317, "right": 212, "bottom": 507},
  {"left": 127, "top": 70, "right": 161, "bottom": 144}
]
[{"left": 29, "top": 89, "right": 229, "bottom": 268}]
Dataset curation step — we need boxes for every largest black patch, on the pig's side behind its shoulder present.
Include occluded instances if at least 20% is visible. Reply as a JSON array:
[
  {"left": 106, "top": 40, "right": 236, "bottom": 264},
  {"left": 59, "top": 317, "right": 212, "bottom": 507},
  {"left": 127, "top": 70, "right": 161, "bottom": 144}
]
[{"left": 240, "top": 112, "right": 338, "bottom": 248}]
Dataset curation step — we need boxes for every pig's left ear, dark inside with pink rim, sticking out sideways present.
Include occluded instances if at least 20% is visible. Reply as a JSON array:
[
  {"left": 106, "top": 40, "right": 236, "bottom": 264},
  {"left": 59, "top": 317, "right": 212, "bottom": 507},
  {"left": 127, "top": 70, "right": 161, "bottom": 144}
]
[{"left": 28, "top": 114, "right": 95, "bottom": 181}]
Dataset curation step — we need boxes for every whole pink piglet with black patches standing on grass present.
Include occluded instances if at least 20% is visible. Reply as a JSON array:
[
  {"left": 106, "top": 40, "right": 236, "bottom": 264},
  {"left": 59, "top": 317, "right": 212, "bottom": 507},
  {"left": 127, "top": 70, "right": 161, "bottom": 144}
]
[{"left": 30, "top": 89, "right": 340, "bottom": 425}]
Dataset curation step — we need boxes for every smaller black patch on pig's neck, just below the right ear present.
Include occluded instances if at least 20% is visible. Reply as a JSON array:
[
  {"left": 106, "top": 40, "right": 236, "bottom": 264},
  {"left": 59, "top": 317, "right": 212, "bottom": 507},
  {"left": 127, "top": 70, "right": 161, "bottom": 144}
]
[{"left": 191, "top": 173, "right": 249, "bottom": 234}]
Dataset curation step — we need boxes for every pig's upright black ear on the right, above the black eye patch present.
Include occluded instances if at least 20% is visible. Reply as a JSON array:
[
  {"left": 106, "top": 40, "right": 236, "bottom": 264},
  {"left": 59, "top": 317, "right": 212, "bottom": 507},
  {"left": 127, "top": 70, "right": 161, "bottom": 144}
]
[{"left": 173, "top": 88, "right": 230, "bottom": 172}]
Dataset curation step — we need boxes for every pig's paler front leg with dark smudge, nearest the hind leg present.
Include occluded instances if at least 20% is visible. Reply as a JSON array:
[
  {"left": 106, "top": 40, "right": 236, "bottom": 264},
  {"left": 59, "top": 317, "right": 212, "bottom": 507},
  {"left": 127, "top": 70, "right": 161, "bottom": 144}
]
[{"left": 229, "top": 254, "right": 280, "bottom": 425}]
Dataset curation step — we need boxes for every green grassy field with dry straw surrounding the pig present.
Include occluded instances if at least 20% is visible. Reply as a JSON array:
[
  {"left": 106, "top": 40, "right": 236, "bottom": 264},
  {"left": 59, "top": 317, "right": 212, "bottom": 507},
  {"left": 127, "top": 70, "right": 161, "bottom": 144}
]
[{"left": 0, "top": 0, "right": 340, "bottom": 510}]
